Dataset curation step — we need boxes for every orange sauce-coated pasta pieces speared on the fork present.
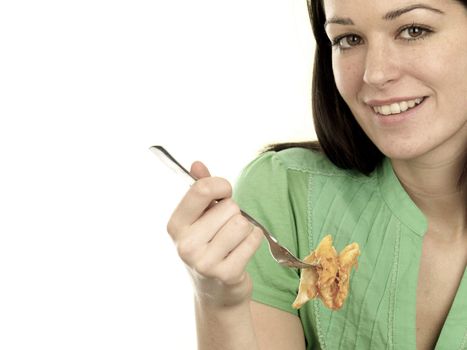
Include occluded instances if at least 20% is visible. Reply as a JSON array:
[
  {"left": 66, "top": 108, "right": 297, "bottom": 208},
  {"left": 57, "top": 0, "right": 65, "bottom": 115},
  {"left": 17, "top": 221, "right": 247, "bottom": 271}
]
[{"left": 292, "top": 235, "right": 360, "bottom": 310}]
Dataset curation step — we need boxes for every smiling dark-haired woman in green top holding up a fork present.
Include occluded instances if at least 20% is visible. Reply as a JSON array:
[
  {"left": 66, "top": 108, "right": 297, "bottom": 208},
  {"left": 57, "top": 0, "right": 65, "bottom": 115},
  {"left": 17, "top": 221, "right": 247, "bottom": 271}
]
[{"left": 168, "top": 0, "right": 467, "bottom": 350}]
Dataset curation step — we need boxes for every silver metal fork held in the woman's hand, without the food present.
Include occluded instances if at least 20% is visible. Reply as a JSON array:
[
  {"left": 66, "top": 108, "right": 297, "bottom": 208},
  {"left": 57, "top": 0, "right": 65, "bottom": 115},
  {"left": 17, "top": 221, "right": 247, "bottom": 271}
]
[{"left": 149, "top": 146, "right": 318, "bottom": 269}]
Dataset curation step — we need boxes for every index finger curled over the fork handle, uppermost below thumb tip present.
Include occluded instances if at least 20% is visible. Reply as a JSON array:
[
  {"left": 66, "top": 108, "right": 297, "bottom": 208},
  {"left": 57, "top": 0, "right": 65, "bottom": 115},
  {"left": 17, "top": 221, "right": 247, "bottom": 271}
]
[{"left": 167, "top": 177, "right": 232, "bottom": 235}]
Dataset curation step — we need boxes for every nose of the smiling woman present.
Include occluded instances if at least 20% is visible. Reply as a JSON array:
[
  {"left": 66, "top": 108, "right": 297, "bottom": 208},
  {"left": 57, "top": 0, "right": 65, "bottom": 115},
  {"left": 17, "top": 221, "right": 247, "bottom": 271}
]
[{"left": 363, "top": 41, "right": 400, "bottom": 89}]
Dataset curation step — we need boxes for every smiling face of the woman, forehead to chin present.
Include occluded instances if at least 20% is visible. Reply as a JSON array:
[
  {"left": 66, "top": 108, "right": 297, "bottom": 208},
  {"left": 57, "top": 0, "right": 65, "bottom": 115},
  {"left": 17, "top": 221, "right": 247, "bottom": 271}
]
[{"left": 323, "top": 0, "right": 467, "bottom": 159}]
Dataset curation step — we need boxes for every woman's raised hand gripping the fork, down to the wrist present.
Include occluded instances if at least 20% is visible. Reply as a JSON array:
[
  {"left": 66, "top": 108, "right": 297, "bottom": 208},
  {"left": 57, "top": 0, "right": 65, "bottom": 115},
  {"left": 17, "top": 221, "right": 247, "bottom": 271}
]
[{"left": 167, "top": 162, "right": 263, "bottom": 307}]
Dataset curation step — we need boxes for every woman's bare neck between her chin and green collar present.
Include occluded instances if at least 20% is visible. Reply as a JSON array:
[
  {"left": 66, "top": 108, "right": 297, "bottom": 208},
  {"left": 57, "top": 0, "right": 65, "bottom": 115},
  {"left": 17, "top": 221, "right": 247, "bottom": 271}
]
[{"left": 392, "top": 152, "right": 467, "bottom": 237}]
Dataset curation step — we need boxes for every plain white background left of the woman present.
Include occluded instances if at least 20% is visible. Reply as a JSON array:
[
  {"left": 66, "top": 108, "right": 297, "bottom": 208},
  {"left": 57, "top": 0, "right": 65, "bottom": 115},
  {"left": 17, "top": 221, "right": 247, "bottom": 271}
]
[{"left": 0, "top": 0, "right": 314, "bottom": 350}]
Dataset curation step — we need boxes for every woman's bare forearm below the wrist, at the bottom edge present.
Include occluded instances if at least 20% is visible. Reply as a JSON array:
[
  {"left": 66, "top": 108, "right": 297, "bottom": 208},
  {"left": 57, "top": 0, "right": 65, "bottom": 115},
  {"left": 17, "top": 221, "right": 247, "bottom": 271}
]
[{"left": 195, "top": 300, "right": 258, "bottom": 350}]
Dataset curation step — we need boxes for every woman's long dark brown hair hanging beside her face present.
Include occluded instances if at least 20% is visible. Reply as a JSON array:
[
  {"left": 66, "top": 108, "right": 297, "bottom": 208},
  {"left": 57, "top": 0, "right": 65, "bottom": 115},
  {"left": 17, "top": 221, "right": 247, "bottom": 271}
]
[{"left": 268, "top": 0, "right": 383, "bottom": 174}]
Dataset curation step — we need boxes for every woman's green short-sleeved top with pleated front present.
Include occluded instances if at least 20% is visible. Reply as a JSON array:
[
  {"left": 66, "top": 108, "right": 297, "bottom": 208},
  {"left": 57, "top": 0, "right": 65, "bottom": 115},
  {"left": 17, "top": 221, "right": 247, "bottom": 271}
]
[{"left": 234, "top": 148, "right": 467, "bottom": 350}]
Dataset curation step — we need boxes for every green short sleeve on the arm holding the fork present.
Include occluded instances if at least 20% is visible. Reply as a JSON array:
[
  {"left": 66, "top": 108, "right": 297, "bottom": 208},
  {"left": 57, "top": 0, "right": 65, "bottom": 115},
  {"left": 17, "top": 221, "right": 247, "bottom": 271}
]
[{"left": 234, "top": 151, "right": 300, "bottom": 315}]
